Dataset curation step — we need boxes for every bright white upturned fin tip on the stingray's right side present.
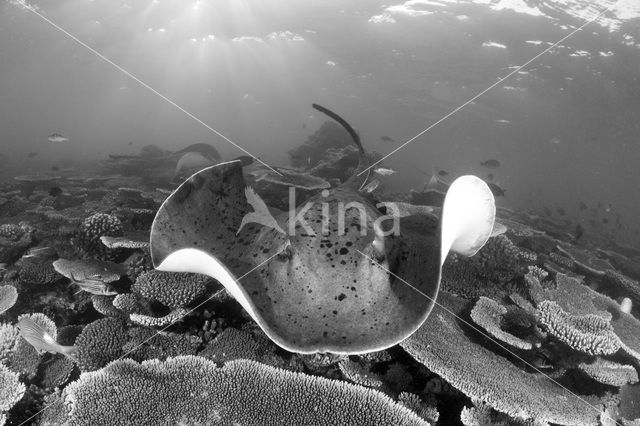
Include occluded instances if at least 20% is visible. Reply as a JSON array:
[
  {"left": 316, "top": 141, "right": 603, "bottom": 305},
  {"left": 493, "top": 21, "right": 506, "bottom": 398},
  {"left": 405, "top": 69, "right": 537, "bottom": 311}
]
[{"left": 440, "top": 175, "right": 496, "bottom": 264}]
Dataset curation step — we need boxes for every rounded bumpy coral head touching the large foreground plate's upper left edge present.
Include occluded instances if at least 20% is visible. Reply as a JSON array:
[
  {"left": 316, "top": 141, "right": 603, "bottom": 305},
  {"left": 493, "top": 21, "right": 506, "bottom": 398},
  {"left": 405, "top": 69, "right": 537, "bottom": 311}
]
[{"left": 75, "top": 318, "right": 129, "bottom": 372}]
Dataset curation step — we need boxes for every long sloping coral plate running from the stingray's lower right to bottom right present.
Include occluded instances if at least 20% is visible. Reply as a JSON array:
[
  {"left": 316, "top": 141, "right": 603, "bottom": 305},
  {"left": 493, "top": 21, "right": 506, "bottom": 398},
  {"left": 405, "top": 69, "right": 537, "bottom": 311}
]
[{"left": 400, "top": 293, "right": 600, "bottom": 425}]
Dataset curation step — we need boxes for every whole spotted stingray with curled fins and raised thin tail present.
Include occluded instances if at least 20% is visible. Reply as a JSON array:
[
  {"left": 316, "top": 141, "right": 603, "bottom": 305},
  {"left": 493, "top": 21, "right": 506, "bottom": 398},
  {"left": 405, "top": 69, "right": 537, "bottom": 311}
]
[{"left": 150, "top": 105, "right": 495, "bottom": 354}]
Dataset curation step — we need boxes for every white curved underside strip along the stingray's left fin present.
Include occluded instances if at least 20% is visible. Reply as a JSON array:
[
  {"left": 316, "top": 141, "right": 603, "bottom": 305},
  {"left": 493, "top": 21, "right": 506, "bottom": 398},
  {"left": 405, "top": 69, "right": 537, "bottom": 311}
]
[{"left": 156, "top": 248, "right": 261, "bottom": 323}]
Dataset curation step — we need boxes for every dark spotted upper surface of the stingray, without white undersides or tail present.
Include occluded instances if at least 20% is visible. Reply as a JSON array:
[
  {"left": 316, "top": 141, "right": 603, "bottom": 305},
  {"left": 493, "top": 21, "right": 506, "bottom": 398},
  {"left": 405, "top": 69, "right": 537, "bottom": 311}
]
[{"left": 151, "top": 162, "right": 440, "bottom": 353}]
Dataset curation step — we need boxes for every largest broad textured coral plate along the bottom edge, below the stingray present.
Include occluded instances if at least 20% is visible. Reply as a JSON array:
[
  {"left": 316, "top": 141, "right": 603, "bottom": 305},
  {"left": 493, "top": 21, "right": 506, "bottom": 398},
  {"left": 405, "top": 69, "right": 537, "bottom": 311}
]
[{"left": 42, "top": 356, "right": 428, "bottom": 426}]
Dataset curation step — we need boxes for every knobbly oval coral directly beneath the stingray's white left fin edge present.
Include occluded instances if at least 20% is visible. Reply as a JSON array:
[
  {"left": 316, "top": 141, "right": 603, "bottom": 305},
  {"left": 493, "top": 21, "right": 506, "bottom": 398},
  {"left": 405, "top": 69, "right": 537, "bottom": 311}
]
[{"left": 132, "top": 270, "right": 211, "bottom": 308}]
